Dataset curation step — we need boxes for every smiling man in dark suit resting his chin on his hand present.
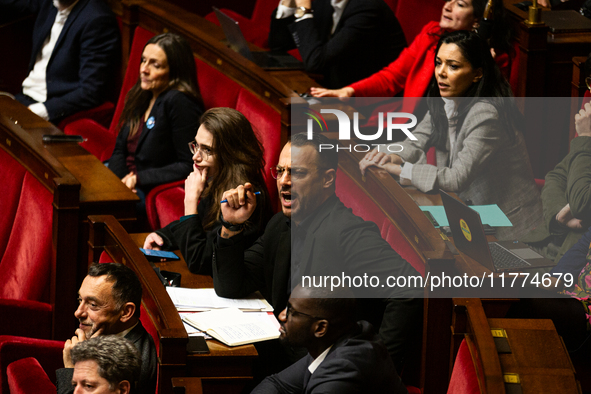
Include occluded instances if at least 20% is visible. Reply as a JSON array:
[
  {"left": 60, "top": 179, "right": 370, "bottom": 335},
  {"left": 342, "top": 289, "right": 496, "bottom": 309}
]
[{"left": 56, "top": 263, "right": 158, "bottom": 394}]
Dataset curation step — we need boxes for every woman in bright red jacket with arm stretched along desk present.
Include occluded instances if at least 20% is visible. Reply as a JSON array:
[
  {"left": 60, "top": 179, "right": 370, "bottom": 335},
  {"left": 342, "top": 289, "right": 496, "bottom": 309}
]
[{"left": 311, "top": 0, "right": 512, "bottom": 107}]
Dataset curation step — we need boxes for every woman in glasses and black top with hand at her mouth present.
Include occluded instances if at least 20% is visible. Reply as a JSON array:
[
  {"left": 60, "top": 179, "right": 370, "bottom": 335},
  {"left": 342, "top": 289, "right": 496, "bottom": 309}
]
[{"left": 144, "top": 108, "right": 272, "bottom": 275}]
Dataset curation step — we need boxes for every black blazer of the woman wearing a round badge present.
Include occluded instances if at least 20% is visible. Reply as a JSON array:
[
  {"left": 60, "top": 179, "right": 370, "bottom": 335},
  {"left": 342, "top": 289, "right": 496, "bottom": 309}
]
[{"left": 109, "top": 90, "right": 203, "bottom": 192}]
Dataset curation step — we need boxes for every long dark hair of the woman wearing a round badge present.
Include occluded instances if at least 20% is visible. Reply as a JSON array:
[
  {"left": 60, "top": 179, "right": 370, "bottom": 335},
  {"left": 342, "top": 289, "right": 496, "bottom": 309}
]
[{"left": 119, "top": 33, "right": 201, "bottom": 136}]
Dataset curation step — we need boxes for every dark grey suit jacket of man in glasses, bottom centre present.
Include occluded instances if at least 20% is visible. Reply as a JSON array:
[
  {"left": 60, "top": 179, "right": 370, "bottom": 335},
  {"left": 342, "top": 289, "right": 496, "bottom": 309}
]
[{"left": 253, "top": 321, "right": 407, "bottom": 394}]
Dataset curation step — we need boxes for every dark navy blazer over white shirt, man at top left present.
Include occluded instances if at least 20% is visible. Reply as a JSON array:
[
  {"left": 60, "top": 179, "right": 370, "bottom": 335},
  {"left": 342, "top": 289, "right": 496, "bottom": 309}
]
[{"left": 0, "top": 0, "right": 121, "bottom": 122}]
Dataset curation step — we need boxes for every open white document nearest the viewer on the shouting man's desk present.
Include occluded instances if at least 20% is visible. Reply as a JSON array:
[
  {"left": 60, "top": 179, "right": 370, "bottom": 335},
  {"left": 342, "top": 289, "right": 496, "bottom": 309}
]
[{"left": 183, "top": 308, "right": 279, "bottom": 346}]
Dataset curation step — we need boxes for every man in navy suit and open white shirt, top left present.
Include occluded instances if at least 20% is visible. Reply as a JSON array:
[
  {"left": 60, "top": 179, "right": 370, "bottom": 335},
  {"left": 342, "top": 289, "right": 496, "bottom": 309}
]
[{"left": 0, "top": 0, "right": 121, "bottom": 123}]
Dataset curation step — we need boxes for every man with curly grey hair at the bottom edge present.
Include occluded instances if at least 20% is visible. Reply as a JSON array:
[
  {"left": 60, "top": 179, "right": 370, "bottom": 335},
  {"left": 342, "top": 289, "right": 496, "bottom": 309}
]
[{"left": 71, "top": 336, "right": 142, "bottom": 394}]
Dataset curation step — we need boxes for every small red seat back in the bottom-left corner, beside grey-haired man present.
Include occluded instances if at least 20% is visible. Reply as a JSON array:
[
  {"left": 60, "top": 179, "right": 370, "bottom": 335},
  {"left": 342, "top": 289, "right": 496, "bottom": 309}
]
[{"left": 7, "top": 357, "right": 56, "bottom": 394}]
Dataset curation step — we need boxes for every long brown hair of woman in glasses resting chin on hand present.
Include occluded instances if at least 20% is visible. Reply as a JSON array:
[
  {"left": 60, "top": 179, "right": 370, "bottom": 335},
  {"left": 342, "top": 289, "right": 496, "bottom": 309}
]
[{"left": 201, "top": 108, "right": 271, "bottom": 230}]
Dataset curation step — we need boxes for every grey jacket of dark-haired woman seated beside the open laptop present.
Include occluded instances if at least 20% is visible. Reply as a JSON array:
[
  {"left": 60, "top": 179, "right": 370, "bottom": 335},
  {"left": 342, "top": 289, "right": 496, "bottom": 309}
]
[{"left": 398, "top": 102, "right": 543, "bottom": 240}]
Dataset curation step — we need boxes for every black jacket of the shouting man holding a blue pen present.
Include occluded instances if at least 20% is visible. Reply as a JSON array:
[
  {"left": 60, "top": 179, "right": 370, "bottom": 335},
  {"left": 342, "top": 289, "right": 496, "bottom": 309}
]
[{"left": 213, "top": 195, "right": 422, "bottom": 365}]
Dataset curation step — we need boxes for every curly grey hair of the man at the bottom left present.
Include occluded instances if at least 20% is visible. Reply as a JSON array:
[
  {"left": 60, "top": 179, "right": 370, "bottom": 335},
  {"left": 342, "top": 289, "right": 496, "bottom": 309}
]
[{"left": 70, "top": 336, "right": 142, "bottom": 393}]
